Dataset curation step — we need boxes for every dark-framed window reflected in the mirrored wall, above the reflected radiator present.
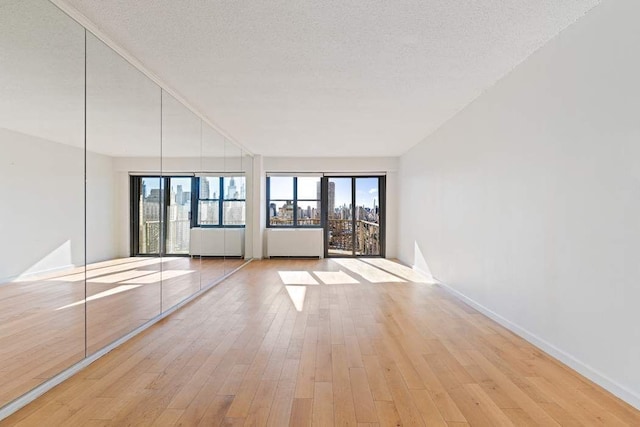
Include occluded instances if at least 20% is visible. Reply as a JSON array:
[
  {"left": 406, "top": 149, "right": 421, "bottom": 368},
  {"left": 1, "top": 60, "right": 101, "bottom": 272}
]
[{"left": 195, "top": 176, "right": 247, "bottom": 227}]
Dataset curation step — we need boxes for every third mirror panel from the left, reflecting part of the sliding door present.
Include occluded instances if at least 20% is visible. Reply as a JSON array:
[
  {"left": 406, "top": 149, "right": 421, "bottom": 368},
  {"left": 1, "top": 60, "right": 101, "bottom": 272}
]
[{"left": 162, "top": 91, "right": 202, "bottom": 311}]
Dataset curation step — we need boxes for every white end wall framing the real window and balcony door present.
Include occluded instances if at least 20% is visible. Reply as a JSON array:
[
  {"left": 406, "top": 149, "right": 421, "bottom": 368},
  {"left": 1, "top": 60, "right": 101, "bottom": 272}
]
[{"left": 257, "top": 157, "right": 398, "bottom": 258}]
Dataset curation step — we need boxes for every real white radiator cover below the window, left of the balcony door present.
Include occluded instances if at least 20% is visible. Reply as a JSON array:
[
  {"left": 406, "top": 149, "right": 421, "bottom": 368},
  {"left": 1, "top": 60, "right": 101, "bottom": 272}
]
[{"left": 267, "top": 228, "right": 324, "bottom": 258}]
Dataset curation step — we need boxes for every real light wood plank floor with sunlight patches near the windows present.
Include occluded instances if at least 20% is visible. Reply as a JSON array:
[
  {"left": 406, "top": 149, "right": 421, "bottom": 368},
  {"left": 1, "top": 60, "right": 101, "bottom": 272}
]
[{"left": 0, "top": 260, "right": 640, "bottom": 427}]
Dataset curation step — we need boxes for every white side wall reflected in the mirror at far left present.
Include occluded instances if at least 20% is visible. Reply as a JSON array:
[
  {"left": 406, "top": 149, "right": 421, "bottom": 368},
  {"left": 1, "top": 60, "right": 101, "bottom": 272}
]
[{"left": 0, "top": 129, "right": 115, "bottom": 282}]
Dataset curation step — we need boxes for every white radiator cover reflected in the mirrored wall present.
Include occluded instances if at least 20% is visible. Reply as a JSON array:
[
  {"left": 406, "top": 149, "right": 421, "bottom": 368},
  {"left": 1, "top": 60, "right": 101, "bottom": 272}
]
[{"left": 189, "top": 228, "right": 244, "bottom": 257}]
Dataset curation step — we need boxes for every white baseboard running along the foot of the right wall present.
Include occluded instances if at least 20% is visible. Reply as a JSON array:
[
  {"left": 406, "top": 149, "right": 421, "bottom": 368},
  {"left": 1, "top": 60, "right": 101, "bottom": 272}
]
[{"left": 430, "top": 278, "right": 640, "bottom": 409}]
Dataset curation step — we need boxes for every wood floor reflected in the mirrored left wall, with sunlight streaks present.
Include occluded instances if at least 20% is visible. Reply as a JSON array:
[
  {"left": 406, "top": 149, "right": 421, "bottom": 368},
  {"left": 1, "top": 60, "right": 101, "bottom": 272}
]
[{"left": 0, "top": 257, "right": 245, "bottom": 406}]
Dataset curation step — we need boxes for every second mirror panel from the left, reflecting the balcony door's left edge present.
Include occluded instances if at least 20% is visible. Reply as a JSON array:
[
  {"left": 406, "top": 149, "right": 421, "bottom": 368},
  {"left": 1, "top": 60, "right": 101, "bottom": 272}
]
[{"left": 86, "top": 33, "right": 162, "bottom": 354}]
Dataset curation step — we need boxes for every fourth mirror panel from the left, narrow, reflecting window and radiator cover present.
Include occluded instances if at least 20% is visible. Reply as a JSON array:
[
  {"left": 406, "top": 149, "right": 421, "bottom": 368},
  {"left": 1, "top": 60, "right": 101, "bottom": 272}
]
[{"left": 202, "top": 123, "right": 230, "bottom": 287}]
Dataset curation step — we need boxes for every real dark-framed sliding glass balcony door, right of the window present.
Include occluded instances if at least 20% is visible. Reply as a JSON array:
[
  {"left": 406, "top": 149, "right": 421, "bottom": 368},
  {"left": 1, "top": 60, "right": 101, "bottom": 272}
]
[{"left": 323, "top": 176, "right": 385, "bottom": 257}]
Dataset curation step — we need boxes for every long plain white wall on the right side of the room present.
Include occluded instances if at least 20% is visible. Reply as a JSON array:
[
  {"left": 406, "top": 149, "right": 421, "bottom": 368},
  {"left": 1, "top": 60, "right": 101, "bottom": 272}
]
[{"left": 399, "top": 0, "right": 640, "bottom": 407}]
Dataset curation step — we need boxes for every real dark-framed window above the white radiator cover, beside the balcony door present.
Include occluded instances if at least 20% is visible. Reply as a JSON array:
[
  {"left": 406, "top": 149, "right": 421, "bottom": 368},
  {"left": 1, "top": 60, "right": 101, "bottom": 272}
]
[{"left": 267, "top": 176, "right": 321, "bottom": 227}]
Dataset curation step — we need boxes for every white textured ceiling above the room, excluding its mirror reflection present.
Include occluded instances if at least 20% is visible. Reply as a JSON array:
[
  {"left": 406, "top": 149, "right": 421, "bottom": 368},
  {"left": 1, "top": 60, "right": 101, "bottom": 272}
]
[{"left": 57, "top": 0, "right": 599, "bottom": 156}]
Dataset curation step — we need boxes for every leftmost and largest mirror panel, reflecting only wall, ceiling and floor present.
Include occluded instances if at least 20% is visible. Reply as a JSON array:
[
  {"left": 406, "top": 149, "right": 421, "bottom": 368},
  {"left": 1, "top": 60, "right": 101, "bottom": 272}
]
[{"left": 0, "top": 0, "right": 85, "bottom": 407}]
